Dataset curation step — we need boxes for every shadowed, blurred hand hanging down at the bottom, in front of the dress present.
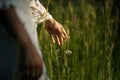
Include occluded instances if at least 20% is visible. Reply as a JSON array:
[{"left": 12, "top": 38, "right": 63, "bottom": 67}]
[{"left": 22, "top": 44, "right": 43, "bottom": 80}]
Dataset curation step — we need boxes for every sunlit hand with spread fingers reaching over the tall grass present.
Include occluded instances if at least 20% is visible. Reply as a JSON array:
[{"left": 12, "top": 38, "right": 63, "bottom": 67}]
[{"left": 45, "top": 18, "right": 68, "bottom": 45}]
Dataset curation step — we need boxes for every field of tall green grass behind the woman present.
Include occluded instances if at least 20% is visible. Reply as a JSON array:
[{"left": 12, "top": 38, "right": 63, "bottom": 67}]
[{"left": 38, "top": 0, "right": 120, "bottom": 80}]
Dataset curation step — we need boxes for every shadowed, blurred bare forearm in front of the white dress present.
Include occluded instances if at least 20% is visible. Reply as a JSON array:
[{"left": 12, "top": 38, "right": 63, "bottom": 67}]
[{"left": 1, "top": 7, "right": 33, "bottom": 47}]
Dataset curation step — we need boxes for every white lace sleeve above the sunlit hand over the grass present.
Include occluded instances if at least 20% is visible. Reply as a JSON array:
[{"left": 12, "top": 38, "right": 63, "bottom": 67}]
[{"left": 30, "top": 0, "right": 52, "bottom": 23}]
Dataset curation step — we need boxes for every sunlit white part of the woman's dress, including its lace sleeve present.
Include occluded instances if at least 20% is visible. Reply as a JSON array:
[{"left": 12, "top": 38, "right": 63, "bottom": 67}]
[{"left": 0, "top": 0, "right": 52, "bottom": 80}]
